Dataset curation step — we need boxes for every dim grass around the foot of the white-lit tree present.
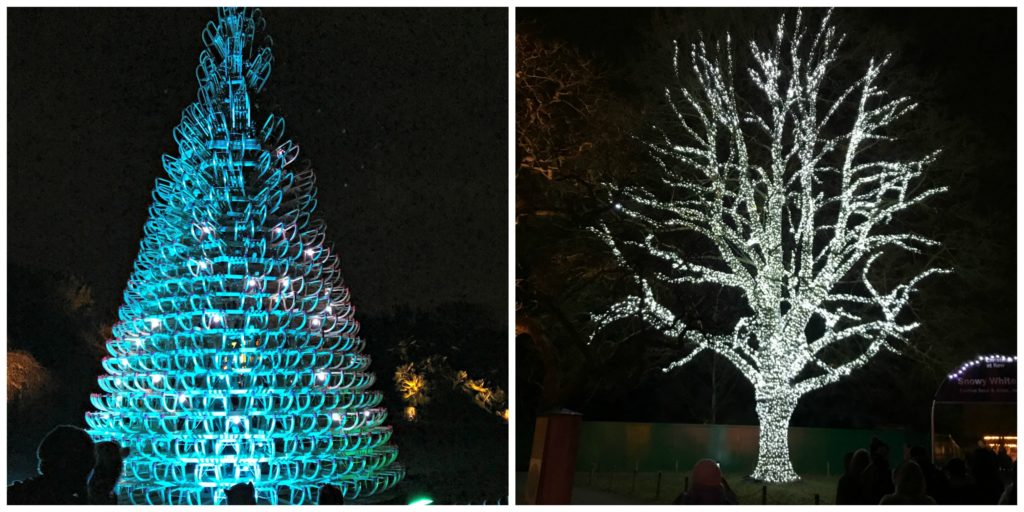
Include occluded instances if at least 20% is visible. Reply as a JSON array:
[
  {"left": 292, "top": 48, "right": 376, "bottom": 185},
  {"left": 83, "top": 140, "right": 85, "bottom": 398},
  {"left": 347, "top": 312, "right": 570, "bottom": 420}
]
[{"left": 575, "top": 471, "right": 839, "bottom": 505}]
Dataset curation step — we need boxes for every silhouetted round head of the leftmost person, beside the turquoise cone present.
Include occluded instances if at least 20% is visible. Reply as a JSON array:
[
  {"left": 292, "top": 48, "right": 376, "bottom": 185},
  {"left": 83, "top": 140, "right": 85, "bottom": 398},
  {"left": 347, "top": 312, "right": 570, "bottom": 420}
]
[{"left": 36, "top": 425, "right": 96, "bottom": 487}]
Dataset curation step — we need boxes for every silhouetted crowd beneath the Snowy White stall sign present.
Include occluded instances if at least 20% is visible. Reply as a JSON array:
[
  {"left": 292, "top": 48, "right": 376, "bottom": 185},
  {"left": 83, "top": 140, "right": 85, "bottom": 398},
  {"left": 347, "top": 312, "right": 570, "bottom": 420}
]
[{"left": 836, "top": 438, "right": 1017, "bottom": 505}]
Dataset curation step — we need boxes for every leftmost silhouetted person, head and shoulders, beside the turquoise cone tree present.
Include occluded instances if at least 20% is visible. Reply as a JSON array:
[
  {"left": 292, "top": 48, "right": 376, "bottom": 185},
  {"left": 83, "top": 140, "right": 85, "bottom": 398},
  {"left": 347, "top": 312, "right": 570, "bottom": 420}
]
[{"left": 7, "top": 425, "right": 96, "bottom": 505}]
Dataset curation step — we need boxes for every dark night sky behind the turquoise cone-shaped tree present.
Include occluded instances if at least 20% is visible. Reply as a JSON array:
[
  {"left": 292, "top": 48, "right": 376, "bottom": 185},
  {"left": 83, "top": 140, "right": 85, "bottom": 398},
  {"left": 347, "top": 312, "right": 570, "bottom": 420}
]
[{"left": 7, "top": 8, "right": 508, "bottom": 322}]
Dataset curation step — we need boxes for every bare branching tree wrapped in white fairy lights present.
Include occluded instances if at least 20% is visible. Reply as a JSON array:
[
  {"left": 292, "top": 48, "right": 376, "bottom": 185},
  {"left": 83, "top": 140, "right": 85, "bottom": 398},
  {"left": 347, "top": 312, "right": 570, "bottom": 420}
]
[{"left": 593, "top": 12, "right": 947, "bottom": 482}]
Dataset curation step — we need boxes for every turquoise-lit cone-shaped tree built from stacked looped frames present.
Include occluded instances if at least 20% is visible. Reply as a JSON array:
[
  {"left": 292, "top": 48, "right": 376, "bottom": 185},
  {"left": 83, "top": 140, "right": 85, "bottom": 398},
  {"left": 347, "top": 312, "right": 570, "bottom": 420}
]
[{"left": 87, "top": 9, "right": 403, "bottom": 504}]
